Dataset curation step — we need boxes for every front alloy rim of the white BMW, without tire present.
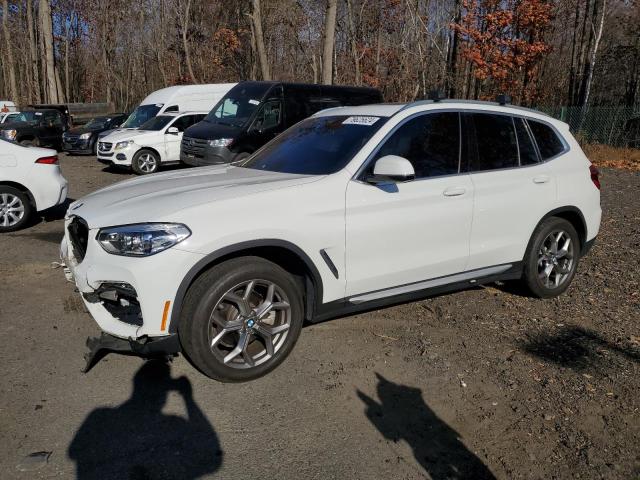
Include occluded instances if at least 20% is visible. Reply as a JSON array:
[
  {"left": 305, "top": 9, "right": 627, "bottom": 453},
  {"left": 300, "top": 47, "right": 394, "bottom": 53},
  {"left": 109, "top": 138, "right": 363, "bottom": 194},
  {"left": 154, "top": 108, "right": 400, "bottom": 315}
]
[{"left": 209, "top": 279, "right": 291, "bottom": 369}]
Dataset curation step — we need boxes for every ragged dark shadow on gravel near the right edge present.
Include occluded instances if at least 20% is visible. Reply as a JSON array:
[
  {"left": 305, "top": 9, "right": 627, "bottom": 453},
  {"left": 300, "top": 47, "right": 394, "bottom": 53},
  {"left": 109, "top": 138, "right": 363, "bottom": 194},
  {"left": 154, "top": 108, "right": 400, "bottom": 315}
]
[{"left": 519, "top": 326, "right": 640, "bottom": 370}]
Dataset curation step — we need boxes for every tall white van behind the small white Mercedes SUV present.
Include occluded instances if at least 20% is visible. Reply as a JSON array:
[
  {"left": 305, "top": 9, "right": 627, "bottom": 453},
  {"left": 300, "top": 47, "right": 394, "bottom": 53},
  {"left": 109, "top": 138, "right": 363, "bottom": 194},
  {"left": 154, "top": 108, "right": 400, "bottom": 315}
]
[{"left": 98, "top": 83, "right": 236, "bottom": 139}]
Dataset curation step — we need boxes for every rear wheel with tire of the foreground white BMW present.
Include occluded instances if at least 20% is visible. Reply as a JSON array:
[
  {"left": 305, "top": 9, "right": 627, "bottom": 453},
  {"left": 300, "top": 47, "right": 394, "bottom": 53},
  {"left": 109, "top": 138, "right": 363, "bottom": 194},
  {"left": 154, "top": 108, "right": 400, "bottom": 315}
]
[{"left": 523, "top": 217, "right": 581, "bottom": 298}]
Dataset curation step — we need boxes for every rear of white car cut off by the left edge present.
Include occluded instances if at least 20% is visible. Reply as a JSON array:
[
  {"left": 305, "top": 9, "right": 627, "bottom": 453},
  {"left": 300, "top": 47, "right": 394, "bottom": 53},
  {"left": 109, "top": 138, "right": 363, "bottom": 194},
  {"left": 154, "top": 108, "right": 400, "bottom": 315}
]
[{"left": 0, "top": 139, "right": 67, "bottom": 233}]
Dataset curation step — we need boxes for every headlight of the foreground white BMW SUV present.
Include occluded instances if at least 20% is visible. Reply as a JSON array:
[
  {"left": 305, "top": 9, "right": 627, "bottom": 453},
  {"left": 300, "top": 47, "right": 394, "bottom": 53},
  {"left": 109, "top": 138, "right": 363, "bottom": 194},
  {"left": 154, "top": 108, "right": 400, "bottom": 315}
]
[{"left": 97, "top": 223, "right": 191, "bottom": 257}]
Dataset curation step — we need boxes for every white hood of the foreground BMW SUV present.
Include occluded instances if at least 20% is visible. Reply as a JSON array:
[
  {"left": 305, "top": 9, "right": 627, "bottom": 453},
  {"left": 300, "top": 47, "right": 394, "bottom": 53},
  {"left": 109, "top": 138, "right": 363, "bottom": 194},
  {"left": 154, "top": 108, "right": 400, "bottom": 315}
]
[{"left": 67, "top": 165, "right": 320, "bottom": 228}]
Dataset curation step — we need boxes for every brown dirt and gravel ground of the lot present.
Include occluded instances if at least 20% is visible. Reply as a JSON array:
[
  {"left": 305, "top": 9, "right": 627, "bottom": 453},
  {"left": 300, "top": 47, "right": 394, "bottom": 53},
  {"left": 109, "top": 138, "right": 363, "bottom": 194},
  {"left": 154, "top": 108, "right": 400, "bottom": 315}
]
[{"left": 0, "top": 154, "right": 640, "bottom": 480}]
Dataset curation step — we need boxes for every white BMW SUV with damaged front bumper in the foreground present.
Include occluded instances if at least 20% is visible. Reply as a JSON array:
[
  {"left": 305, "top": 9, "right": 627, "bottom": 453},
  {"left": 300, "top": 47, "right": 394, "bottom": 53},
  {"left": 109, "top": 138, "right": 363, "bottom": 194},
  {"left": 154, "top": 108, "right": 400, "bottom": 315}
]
[{"left": 61, "top": 100, "right": 601, "bottom": 381}]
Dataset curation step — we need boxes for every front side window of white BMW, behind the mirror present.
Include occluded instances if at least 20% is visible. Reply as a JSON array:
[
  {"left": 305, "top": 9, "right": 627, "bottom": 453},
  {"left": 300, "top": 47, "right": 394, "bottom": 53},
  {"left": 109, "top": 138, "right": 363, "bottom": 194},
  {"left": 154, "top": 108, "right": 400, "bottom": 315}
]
[{"left": 374, "top": 112, "right": 460, "bottom": 178}]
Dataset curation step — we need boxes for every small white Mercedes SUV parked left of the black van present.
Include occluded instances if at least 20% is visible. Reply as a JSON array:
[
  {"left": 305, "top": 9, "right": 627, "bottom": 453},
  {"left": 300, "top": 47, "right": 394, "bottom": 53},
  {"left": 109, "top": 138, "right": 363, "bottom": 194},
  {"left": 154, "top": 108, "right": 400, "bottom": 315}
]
[{"left": 98, "top": 112, "right": 208, "bottom": 175}]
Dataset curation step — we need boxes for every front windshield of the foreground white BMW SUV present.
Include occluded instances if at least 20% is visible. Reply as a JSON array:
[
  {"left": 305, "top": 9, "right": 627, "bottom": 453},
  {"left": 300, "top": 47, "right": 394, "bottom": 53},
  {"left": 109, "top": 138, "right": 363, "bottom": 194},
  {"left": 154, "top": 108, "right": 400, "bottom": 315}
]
[{"left": 239, "top": 115, "right": 387, "bottom": 175}]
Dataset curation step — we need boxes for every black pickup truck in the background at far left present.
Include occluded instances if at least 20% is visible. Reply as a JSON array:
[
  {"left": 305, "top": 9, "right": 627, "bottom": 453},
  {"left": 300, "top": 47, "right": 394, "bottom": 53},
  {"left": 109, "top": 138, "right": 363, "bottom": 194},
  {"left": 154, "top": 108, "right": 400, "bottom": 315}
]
[{"left": 0, "top": 109, "right": 68, "bottom": 150}]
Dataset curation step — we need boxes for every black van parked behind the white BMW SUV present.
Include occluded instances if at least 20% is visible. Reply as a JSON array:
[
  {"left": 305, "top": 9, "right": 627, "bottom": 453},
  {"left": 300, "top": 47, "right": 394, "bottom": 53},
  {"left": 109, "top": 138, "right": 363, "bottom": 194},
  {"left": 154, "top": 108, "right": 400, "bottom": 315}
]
[{"left": 180, "top": 82, "right": 382, "bottom": 166}]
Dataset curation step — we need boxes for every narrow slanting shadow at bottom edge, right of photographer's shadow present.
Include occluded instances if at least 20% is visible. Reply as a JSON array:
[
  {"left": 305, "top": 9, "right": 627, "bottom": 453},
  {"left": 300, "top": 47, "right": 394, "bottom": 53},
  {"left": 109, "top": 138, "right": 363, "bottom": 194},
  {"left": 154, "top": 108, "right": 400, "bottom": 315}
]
[{"left": 358, "top": 374, "right": 495, "bottom": 480}]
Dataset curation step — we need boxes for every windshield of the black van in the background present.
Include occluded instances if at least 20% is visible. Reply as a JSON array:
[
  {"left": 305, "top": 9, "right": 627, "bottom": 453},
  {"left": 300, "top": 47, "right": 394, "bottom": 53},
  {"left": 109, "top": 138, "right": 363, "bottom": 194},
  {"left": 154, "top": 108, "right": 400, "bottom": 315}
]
[{"left": 205, "top": 83, "right": 271, "bottom": 127}]
